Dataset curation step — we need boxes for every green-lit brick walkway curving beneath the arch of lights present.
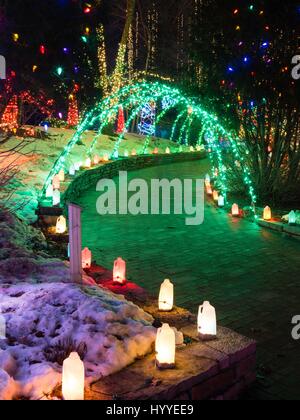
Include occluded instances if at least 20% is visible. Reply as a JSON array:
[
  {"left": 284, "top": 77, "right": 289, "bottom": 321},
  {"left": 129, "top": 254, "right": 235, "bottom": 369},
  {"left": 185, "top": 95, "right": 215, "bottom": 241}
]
[{"left": 77, "top": 161, "right": 300, "bottom": 399}]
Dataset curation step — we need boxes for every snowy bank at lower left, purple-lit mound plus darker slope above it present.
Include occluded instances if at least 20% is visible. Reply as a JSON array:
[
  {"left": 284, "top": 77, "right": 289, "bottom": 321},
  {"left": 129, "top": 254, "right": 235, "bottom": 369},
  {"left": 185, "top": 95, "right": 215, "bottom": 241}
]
[{"left": 0, "top": 211, "right": 155, "bottom": 400}]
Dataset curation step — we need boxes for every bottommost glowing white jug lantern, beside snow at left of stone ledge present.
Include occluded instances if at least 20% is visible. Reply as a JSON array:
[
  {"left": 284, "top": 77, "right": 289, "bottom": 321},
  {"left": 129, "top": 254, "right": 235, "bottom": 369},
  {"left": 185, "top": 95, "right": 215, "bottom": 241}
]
[{"left": 62, "top": 353, "right": 85, "bottom": 401}]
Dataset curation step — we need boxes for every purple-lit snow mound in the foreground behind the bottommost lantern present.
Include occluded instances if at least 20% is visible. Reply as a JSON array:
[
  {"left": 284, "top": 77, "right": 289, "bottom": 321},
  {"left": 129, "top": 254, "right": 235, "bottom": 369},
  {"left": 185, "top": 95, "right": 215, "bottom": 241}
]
[{"left": 0, "top": 283, "right": 155, "bottom": 399}]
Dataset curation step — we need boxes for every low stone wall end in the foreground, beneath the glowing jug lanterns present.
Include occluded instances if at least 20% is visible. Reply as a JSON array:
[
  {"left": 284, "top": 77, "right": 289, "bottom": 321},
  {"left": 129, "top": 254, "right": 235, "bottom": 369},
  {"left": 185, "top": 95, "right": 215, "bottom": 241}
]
[{"left": 87, "top": 325, "right": 256, "bottom": 401}]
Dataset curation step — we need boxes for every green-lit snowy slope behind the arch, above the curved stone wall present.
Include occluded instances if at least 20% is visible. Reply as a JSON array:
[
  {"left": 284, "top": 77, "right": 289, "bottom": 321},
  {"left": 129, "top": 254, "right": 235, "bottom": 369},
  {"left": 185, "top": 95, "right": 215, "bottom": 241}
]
[{"left": 0, "top": 128, "right": 185, "bottom": 223}]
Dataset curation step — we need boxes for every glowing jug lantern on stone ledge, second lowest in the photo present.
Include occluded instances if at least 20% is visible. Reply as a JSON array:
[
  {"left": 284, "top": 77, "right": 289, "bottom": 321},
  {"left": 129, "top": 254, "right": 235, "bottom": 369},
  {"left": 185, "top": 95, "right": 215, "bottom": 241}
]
[{"left": 155, "top": 324, "right": 176, "bottom": 369}]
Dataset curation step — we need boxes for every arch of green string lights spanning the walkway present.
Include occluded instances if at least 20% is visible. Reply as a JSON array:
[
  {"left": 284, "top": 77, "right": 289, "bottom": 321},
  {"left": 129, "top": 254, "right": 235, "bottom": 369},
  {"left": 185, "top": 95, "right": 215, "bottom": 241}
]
[{"left": 42, "top": 82, "right": 257, "bottom": 209}]
